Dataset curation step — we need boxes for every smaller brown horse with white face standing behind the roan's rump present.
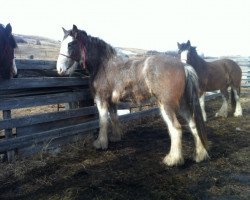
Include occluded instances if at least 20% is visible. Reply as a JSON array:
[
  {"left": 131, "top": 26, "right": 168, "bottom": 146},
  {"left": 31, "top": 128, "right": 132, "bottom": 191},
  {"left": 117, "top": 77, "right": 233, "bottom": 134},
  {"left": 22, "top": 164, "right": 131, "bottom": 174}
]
[{"left": 177, "top": 40, "right": 242, "bottom": 121}]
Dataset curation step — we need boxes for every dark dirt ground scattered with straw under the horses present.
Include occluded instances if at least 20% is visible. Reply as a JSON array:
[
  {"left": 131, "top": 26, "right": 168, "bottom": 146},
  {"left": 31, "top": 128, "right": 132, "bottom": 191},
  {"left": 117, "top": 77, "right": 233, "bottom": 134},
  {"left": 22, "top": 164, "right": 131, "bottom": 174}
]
[{"left": 0, "top": 95, "right": 250, "bottom": 200}]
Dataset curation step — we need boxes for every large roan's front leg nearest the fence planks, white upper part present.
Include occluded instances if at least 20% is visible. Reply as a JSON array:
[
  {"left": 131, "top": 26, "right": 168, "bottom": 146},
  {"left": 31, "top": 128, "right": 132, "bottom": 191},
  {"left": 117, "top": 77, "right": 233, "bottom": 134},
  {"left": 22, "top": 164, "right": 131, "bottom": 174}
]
[{"left": 93, "top": 97, "right": 108, "bottom": 149}]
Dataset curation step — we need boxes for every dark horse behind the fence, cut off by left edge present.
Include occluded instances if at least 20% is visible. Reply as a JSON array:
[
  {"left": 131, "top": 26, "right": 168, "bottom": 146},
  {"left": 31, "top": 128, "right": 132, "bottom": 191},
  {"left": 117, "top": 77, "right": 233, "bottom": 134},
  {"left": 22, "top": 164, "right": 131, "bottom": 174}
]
[{"left": 0, "top": 24, "right": 17, "bottom": 79}]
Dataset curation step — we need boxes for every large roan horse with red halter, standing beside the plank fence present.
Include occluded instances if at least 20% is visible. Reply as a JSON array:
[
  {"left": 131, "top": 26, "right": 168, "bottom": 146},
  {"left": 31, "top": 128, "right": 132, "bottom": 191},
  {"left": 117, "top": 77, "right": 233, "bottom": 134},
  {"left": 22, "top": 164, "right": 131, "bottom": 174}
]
[{"left": 57, "top": 25, "right": 208, "bottom": 166}]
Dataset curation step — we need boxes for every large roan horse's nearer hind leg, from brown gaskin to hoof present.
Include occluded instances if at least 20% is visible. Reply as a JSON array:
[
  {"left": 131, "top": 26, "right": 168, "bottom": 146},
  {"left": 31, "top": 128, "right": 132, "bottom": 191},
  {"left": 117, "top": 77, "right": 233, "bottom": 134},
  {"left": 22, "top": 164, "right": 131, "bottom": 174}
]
[{"left": 160, "top": 104, "right": 184, "bottom": 166}]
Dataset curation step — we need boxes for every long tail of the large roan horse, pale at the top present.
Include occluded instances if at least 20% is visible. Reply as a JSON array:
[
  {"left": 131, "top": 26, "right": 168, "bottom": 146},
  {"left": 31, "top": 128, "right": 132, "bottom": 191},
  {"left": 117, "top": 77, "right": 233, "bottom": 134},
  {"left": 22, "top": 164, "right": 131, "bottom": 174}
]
[{"left": 184, "top": 65, "right": 208, "bottom": 149}]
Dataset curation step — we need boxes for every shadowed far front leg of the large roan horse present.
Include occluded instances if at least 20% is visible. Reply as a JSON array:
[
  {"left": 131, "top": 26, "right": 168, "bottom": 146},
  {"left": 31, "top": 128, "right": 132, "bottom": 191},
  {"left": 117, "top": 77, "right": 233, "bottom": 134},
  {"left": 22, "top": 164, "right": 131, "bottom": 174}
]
[{"left": 109, "top": 103, "right": 122, "bottom": 142}]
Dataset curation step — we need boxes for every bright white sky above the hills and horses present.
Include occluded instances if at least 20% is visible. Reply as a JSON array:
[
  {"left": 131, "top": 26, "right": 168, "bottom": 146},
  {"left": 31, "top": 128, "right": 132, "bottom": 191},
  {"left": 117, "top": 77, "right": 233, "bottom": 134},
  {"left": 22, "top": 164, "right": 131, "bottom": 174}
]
[{"left": 0, "top": 0, "right": 250, "bottom": 56}]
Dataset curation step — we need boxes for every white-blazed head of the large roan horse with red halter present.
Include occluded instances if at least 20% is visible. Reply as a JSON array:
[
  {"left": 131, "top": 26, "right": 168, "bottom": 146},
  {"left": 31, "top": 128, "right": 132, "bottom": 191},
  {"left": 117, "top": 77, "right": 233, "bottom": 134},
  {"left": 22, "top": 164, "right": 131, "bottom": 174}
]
[{"left": 56, "top": 25, "right": 87, "bottom": 75}]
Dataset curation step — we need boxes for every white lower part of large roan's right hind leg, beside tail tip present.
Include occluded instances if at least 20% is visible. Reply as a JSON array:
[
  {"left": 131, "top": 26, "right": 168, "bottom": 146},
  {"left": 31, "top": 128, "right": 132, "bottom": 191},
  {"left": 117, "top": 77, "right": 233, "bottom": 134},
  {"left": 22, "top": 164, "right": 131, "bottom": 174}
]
[{"left": 188, "top": 118, "right": 209, "bottom": 162}]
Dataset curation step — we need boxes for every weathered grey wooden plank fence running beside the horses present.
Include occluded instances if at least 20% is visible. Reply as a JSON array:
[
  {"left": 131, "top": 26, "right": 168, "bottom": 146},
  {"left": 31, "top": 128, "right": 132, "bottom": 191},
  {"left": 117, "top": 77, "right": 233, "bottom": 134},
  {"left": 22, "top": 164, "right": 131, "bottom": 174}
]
[{"left": 0, "top": 57, "right": 250, "bottom": 160}]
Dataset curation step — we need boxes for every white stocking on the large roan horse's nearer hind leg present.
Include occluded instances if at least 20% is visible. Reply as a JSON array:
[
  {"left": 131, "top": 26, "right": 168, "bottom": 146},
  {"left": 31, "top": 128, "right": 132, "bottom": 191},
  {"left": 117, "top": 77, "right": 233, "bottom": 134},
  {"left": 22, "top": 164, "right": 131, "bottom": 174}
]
[{"left": 160, "top": 105, "right": 184, "bottom": 166}]
